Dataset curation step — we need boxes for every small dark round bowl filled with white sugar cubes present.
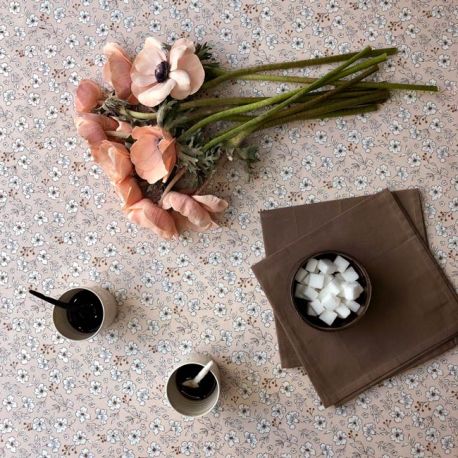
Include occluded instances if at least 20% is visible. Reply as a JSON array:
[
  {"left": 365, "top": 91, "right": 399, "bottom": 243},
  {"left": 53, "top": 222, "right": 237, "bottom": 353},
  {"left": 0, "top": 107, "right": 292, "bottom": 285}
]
[{"left": 292, "top": 251, "right": 372, "bottom": 331}]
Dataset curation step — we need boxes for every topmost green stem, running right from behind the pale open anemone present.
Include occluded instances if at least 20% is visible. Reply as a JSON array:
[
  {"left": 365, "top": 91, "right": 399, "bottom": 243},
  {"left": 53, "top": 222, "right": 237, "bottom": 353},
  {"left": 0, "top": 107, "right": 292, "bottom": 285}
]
[{"left": 203, "top": 48, "right": 397, "bottom": 89}]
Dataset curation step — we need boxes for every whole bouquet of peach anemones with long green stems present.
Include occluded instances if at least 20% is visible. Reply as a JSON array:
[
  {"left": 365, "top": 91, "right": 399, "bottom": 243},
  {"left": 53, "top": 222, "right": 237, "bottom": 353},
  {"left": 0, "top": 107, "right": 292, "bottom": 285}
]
[{"left": 75, "top": 37, "right": 437, "bottom": 238}]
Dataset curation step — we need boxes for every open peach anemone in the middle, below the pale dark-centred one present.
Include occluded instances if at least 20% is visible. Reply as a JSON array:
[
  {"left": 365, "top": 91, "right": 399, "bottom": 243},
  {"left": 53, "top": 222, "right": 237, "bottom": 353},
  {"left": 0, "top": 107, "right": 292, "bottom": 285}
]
[{"left": 130, "top": 126, "right": 177, "bottom": 184}]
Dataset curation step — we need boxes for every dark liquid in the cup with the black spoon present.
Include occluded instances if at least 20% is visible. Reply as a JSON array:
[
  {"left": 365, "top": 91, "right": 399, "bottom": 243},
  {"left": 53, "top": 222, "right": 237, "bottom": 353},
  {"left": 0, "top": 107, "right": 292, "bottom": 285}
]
[{"left": 67, "top": 291, "right": 103, "bottom": 334}]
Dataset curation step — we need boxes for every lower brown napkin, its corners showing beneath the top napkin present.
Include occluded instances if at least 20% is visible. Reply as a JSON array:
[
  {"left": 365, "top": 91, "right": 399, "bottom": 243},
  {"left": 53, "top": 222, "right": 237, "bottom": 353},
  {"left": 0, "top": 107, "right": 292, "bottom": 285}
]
[{"left": 261, "top": 189, "right": 430, "bottom": 368}]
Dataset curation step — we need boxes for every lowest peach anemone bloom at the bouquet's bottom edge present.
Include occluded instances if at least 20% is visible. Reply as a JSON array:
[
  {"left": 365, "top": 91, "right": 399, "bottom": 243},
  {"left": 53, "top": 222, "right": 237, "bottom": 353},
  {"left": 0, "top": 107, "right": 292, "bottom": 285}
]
[{"left": 126, "top": 199, "right": 178, "bottom": 239}]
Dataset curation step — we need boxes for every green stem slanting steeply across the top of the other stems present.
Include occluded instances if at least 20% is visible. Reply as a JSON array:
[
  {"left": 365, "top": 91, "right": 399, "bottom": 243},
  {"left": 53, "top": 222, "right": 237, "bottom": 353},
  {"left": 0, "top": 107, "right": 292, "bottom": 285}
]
[{"left": 203, "top": 46, "right": 371, "bottom": 151}]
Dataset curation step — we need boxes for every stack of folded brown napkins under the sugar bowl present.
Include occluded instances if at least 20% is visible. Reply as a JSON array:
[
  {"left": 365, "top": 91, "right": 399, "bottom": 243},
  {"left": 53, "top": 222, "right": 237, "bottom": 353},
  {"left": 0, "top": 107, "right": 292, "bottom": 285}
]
[{"left": 253, "top": 190, "right": 458, "bottom": 406}]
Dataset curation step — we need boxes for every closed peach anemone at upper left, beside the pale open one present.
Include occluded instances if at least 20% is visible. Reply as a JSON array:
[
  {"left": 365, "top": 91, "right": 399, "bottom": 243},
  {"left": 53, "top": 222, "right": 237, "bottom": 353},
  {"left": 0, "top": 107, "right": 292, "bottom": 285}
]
[{"left": 103, "top": 42, "right": 137, "bottom": 104}]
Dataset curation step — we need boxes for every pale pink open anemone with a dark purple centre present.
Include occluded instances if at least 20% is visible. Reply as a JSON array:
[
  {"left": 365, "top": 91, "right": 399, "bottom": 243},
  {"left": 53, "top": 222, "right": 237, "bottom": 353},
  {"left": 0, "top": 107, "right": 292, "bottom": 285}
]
[{"left": 131, "top": 37, "right": 205, "bottom": 107}]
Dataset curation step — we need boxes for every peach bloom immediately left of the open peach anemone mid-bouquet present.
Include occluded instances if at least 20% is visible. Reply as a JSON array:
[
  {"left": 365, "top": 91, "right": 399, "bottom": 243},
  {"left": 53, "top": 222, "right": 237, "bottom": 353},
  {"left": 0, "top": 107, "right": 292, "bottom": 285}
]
[{"left": 92, "top": 140, "right": 134, "bottom": 184}]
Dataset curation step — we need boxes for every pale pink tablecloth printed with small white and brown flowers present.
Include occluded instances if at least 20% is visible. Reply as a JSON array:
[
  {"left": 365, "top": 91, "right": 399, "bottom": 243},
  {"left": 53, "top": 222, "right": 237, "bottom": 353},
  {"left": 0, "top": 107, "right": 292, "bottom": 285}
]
[{"left": 0, "top": 0, "right": 458, "bottom": 458}]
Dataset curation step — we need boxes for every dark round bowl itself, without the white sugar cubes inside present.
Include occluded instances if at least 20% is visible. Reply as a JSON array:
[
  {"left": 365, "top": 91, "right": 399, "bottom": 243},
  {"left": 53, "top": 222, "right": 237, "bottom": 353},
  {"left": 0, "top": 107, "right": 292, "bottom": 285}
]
[{"left": 291, "top": 251, "right": 372, "bottom": 331}]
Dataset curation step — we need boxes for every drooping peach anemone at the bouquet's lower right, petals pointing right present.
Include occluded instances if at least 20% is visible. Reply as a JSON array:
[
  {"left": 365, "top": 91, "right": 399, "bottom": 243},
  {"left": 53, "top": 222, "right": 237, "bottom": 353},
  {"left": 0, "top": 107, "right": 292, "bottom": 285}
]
[{"left": 162, "top": 191, "right": 228, "bottom": 231}]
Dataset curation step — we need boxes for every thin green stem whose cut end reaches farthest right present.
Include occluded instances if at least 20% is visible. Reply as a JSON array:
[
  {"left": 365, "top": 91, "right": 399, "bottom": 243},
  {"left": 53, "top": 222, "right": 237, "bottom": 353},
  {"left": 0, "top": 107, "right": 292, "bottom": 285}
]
[{"left": 227, "top": 74, "right": 439, "bottom": 92}]
